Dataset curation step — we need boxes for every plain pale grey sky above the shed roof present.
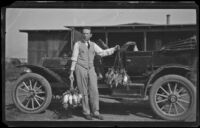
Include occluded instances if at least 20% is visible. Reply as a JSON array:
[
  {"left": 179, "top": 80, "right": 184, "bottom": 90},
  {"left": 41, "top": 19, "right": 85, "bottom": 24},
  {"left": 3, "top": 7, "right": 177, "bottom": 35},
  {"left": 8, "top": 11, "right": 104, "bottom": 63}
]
[{"left": 5, "top": 8, "right": 196, "bottom": 58}]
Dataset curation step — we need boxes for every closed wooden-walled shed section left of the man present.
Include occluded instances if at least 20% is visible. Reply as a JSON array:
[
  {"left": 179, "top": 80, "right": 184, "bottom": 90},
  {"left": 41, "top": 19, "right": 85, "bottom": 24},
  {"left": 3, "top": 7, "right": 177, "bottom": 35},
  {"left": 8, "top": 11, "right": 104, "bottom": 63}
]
[{"left": 20, "top": 29, "right": 71, "bottom": 65}]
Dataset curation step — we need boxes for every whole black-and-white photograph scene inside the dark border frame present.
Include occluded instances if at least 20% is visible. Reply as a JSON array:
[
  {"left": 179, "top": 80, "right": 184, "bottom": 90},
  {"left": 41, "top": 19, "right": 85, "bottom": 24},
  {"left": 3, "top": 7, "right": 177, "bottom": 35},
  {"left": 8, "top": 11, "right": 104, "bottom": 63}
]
[{"left": 2, "top": 1, "right": 199, "bottom": 127}]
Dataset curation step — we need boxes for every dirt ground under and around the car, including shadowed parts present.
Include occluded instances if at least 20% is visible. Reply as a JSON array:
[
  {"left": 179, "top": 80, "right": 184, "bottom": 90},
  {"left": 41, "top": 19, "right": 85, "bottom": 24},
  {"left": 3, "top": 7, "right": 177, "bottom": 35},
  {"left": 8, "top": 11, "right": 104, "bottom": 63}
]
[{"left": 5, "top": 81, "right": 195, "bottom": 126}]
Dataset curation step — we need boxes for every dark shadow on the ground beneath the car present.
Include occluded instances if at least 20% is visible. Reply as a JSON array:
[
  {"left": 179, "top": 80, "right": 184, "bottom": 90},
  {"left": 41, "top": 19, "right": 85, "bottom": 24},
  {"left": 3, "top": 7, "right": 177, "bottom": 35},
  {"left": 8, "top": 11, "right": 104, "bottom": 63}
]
[{"left": 48, "top": 98, "right": 160, "bottom": 119}]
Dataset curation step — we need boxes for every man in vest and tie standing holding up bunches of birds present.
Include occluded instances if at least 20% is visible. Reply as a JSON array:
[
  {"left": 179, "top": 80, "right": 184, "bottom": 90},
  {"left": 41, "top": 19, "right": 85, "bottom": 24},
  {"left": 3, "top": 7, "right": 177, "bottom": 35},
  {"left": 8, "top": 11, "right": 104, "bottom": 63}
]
[{"left": 69, "top": 28, "right": 119, "bottom": 120}]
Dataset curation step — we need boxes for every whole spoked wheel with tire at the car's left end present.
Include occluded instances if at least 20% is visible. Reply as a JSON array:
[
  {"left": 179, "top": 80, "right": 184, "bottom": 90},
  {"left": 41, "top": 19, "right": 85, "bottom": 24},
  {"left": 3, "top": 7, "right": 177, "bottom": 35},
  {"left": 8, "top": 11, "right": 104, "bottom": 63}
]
[{"left": 12, "top": 73, "right": 52, "bottom": 113}]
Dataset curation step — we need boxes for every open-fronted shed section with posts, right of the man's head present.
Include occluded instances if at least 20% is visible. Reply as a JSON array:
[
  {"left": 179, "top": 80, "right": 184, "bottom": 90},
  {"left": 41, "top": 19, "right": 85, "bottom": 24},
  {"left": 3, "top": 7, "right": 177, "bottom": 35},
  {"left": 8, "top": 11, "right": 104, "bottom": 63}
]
[{"left": 66, "top": 23, "right": 197, "bottom": 51}]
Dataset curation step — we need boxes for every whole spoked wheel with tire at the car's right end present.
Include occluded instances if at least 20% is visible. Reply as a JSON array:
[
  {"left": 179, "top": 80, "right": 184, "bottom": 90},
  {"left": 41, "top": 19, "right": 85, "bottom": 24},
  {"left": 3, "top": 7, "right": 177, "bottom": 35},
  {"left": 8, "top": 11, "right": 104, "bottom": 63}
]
[{"left": 149, "top": 75, "right": 196, "bottom": 121}]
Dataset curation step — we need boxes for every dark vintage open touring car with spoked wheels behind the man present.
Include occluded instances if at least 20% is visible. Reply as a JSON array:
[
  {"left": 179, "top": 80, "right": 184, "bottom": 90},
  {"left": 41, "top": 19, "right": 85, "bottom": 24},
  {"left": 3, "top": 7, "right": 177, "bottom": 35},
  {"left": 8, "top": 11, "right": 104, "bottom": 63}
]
[{"left": 12, "top": 37, "right": 198, "bottom": 121}]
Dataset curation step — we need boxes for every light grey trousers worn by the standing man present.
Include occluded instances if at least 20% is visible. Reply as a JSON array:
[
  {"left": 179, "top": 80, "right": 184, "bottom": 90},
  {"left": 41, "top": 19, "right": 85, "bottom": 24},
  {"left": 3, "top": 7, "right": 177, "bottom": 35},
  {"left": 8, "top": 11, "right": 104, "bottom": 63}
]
[{"left": 75, "top": 64, "right": 99, "bottom": 115}]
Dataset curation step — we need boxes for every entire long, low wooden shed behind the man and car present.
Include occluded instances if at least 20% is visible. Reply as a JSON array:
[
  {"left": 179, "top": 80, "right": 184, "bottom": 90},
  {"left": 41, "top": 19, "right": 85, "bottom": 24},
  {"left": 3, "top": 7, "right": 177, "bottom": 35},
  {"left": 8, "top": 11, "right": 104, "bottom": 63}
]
[{"left": 20, "top": 23, "right": 197, "bottom": 65}]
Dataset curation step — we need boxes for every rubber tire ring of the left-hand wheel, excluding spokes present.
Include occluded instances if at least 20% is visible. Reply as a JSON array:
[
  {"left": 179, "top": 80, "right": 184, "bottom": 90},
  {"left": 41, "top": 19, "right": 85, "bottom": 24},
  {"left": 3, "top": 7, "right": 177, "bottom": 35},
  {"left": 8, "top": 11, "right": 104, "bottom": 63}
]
[{"left": 12, "top": 73, "right": 52, "bottom": 113}]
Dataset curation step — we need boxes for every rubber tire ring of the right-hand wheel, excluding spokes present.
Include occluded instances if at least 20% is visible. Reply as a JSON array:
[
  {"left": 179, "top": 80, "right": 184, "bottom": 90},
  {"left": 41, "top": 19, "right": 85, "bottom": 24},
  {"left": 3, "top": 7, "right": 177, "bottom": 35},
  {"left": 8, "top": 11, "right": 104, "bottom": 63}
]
[{"left": 149, "top": 75, "right": 196, "bottom": 121}]
